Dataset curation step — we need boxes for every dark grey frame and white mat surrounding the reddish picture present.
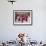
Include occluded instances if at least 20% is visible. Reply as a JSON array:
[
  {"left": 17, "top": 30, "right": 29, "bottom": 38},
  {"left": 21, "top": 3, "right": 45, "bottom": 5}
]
[{"left": 13, "top": 10, "right": 33, "bottom": 26}]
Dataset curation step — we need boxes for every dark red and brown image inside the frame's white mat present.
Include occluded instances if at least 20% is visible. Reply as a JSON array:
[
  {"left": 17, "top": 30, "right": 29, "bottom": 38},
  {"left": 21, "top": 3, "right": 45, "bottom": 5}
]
[{"left": 15, "top": 12, "right": 30, "bottom": 23}]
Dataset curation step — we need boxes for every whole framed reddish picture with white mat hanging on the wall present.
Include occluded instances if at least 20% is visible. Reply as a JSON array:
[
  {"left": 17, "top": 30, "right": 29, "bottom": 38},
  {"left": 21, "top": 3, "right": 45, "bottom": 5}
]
[{"left": 13, "top": 10, "right": 32, "bottom": 25}]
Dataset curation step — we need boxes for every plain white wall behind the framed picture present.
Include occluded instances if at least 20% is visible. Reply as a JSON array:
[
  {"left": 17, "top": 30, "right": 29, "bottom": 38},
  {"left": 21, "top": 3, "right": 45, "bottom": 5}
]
[{"left": 0, "top": 0, "right": 46, "bottom": 41}]
